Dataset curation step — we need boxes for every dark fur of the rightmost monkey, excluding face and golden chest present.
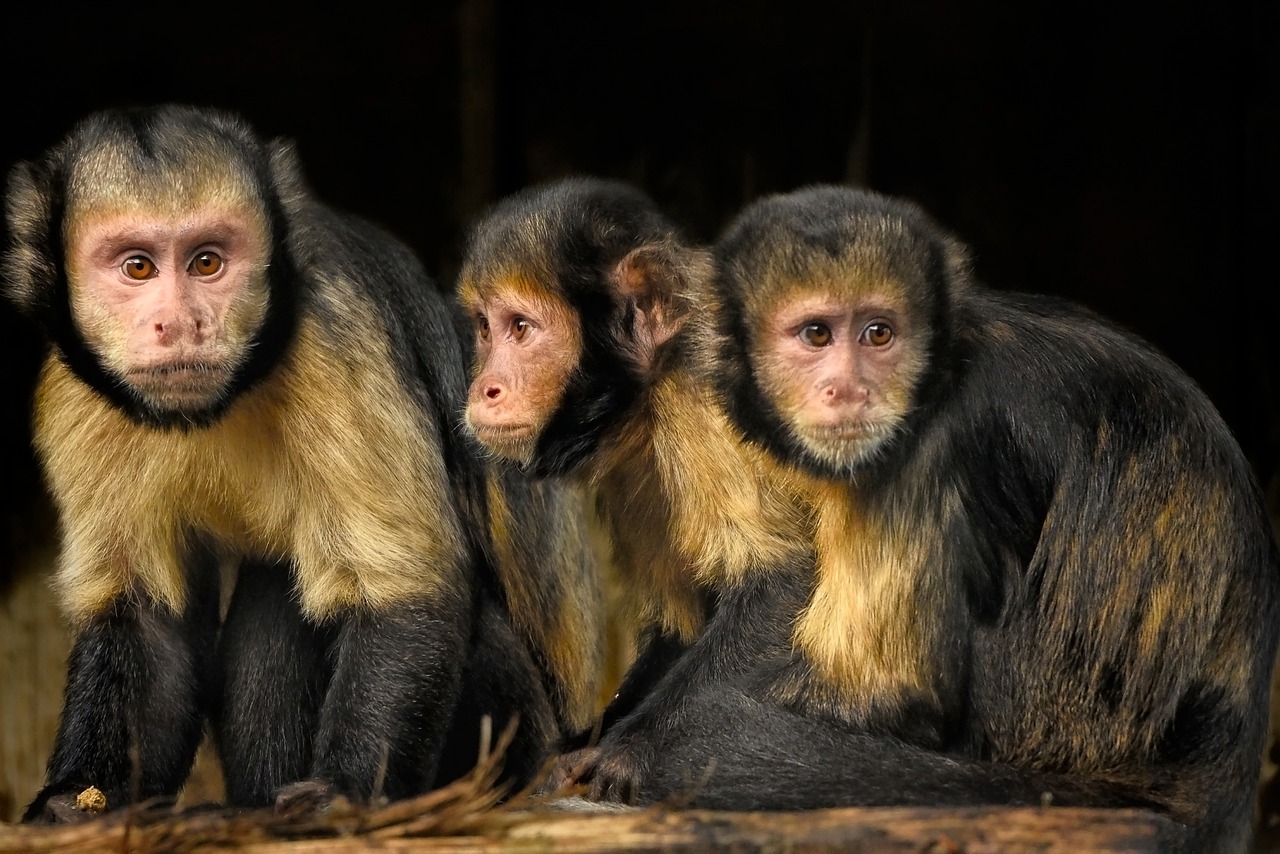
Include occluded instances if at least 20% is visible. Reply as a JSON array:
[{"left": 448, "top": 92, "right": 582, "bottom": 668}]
[{"left": 641, "top": 188, "right": 1280, "bottom": 851}]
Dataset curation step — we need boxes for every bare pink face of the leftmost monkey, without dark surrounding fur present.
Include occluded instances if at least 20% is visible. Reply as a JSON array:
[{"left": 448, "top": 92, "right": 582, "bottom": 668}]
[{"left": 68, "top": 207, "right": 266, "bottom": 412}]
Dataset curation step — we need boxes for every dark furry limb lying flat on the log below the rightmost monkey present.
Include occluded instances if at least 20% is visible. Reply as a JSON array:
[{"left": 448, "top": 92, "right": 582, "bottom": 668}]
[{"left": 640, "top": 685, "right": 1172, "bottom": 809}]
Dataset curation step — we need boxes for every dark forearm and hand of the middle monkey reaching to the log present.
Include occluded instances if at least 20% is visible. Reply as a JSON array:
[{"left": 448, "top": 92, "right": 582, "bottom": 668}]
[{"left": 548, "top": 565, "right": 812, "bottom": 803}]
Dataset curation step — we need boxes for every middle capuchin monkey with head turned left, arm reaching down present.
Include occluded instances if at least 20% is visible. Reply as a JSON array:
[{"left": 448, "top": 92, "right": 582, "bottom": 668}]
[{"left": 458, "top": 177, "right": 813, "bottom": 800}]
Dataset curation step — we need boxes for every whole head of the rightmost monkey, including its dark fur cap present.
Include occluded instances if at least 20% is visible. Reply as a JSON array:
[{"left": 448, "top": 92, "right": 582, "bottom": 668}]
[{"left": 713, "top": 188, "right": 964, "bottom": 478}]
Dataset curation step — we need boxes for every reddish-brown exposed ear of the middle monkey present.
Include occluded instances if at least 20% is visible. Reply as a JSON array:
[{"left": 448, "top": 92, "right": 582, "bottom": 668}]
[{"left": 611, "top": 245, "right": 709, "bottom": 373}]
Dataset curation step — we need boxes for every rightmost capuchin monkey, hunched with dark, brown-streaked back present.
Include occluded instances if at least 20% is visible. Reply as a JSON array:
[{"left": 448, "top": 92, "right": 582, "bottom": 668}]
[{"left": 635, "top": 187, "right": 1280, "bottom": 851}]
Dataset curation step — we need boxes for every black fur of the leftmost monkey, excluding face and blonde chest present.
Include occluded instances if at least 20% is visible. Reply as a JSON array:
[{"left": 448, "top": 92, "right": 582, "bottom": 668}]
[{"left": 6, "top": 106, "right": 600, "bottom": 821}]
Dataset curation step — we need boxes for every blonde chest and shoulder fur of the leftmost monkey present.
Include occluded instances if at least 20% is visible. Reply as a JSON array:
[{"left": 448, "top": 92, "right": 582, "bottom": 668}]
[{"left": 35, "top": 311, "right": 461, "bottom": 620}]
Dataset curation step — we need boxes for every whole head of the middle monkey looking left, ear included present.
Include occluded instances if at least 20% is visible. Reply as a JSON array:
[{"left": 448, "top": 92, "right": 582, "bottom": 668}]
[{"left": 458, "top": 178, "right": 709, "bottom": 476}]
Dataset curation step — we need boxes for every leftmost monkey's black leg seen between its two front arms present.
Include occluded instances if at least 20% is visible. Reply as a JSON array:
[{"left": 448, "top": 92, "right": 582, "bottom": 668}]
[{"left": 214, "top": 561, "right": 334, "bottom": 807}]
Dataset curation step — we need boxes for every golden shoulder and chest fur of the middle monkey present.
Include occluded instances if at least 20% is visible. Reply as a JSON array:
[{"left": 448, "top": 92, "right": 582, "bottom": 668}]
[{"left": 588, "top": 369, "right": 810, "bottom": 641}]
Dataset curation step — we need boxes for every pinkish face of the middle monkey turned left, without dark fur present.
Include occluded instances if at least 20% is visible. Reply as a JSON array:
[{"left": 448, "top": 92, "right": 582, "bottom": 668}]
[{"left": 460, "top": 278, "right": 582, "bottom": 465}]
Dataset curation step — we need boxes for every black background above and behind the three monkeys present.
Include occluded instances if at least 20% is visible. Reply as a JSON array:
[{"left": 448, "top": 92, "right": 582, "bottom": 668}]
[{"left": 0, "top": 0, "right": 1280, "bottom": 555}]
